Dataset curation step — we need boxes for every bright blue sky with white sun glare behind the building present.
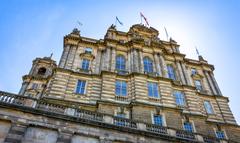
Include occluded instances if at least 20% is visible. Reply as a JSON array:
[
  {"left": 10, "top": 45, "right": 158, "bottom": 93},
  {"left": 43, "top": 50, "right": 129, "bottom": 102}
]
[{"left": 0, "top": 0, "right": 240, "bottom": 123}]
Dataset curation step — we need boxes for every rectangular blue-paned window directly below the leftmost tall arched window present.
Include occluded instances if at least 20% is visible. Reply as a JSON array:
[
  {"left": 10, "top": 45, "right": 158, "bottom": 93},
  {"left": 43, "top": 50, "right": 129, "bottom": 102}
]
[{"left": 115, "top": 80, "right": 127, "bottom": 96}]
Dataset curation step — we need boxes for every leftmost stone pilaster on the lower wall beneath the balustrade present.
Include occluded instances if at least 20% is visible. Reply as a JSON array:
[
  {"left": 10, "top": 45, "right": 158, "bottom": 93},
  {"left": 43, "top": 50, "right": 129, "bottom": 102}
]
[{"left": 4, "top": 123, "right": 27, "bottom": 143}]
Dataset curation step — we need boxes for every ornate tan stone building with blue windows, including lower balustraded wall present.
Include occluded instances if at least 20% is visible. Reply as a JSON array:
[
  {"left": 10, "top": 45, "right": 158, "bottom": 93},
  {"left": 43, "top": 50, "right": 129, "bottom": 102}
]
[{"left": 0, "top": 24, "right": 240, "bottom": 143}]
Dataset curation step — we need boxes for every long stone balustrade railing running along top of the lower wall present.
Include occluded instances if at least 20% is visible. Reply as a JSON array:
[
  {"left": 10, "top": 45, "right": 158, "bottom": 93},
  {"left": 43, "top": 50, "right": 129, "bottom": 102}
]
[{"left": 0, "top": 91, "right": 227, "bottom": 143}]
